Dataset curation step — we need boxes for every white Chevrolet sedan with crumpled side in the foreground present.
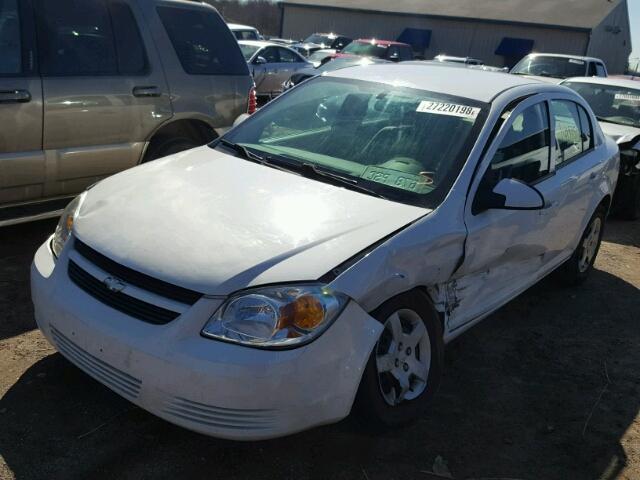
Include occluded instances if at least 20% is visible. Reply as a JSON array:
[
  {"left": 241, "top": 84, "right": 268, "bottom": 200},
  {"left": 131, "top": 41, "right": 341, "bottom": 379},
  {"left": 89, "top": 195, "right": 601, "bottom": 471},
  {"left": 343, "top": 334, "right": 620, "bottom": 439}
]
[{"left": 32, "top": 64, "right": 619, "bottom": 440}]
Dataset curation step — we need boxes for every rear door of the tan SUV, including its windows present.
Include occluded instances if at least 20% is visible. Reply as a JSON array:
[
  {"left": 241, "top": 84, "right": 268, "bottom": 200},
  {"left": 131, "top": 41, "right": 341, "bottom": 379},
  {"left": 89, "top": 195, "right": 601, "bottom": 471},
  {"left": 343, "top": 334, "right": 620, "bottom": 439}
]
[{"left": 33, "top": 0, "right": 171, "bottom": 199}]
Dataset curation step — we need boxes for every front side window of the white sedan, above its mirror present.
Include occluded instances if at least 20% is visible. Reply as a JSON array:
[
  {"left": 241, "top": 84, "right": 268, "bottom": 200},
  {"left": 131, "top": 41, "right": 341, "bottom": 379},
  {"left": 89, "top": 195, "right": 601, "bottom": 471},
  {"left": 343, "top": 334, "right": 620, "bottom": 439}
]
[{"left": 487, "top": 103, "right": 551, "bottom": 184}]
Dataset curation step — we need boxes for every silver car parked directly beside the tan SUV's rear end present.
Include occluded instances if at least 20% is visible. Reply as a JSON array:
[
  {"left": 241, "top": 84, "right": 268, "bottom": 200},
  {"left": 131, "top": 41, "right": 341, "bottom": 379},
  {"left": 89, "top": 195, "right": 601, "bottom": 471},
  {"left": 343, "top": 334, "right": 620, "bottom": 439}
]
[{"left": 238, "top": 40, "right": 313, "bottom": 98}]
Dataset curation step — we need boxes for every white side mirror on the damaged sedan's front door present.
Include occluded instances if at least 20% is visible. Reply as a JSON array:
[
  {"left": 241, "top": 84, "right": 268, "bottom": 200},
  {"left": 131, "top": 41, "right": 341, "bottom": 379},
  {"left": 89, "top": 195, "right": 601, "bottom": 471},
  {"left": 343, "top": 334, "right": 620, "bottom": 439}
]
[{"left": 473, "top": 178, "right": 545, "bottom": 214}]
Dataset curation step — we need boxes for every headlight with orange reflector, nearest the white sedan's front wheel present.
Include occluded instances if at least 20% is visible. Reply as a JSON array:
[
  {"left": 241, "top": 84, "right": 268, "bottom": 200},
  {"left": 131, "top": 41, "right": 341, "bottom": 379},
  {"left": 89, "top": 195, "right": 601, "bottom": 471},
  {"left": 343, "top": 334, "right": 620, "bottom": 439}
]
[{"left": 202, "top": 285, "right": 348, "bottom": 348}]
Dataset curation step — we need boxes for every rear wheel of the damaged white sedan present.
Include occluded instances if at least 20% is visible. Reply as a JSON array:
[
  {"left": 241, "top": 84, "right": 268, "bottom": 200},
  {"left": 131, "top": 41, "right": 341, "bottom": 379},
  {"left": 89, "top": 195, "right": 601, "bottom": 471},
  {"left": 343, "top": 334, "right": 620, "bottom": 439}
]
[{"left": 560, "top": 207, "right": 606, "bottom": 286}]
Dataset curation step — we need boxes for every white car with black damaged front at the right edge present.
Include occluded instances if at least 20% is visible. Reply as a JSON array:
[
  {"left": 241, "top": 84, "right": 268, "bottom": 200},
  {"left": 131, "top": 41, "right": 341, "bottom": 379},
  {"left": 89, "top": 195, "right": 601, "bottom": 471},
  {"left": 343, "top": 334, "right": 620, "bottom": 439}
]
[{"left": 562, "top": 78, "right": 640, "bottom": 220}]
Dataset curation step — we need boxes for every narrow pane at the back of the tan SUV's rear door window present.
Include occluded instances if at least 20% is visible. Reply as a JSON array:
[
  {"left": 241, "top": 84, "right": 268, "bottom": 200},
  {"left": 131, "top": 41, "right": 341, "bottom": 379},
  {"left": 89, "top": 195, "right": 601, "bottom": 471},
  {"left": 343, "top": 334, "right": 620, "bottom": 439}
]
[{"left": 109, "top": 1, "right": 147, "bottom": 75}]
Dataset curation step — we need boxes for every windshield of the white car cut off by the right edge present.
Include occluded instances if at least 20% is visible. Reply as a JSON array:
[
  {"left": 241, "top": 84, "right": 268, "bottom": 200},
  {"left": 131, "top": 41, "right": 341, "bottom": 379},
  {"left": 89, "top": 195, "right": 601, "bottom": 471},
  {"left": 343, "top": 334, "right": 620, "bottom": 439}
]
[{"left": 562, "top": 82, "right": 640, "bottom": 128}]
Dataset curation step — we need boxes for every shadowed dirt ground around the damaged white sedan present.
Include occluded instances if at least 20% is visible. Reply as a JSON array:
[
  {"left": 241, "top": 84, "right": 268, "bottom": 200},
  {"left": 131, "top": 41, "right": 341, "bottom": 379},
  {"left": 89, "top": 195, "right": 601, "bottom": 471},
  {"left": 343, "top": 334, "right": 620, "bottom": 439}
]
[{"left": 0, "top": 221, "right": 640, "bottom": 480}]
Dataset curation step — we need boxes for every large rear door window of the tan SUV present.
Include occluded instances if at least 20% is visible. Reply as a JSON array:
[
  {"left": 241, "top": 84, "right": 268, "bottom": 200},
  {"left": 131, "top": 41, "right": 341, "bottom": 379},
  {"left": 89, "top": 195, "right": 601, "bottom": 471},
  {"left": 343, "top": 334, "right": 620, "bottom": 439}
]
[{"left": 35, "top": 0, "right": 118, "bottom": 75}]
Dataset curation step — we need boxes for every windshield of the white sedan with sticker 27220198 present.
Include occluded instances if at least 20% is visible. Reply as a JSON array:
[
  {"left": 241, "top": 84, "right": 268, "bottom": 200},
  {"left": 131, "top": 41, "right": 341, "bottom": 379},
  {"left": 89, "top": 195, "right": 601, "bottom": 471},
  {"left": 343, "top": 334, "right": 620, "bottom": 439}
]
[{"left": 214, "top": 77, "right": 487, "bottom": 208}]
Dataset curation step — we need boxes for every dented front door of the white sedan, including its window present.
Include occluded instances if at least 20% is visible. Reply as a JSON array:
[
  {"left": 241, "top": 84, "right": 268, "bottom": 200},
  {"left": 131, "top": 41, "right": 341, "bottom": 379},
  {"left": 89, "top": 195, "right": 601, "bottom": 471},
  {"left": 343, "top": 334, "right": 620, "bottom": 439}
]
[{"left": 448, "top": 95, "right": 558, "bottom": 330}]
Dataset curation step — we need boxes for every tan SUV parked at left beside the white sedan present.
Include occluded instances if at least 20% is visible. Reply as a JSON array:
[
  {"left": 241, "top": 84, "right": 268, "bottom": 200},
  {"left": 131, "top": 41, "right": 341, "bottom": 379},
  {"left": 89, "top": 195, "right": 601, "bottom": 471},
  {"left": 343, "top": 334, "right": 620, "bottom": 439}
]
[{"left": 0, "top": 0, "right": 253, "bottom": 226}]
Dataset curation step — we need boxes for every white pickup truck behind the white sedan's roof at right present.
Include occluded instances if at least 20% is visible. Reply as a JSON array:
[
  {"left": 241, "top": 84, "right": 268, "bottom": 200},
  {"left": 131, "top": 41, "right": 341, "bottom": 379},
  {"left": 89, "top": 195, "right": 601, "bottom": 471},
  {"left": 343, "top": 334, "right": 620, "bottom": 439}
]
[{"left": 511, "top": 53, "right": 608, "bottom": 83}]
